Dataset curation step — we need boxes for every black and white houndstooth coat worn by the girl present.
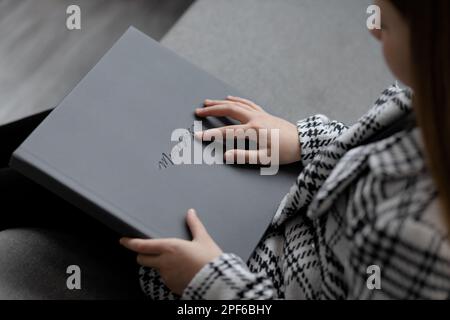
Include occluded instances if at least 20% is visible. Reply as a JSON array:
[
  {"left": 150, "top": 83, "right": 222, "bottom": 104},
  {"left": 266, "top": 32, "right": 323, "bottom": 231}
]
[{"left": 140, "top": 86, "right": 450, "bottom": 299}]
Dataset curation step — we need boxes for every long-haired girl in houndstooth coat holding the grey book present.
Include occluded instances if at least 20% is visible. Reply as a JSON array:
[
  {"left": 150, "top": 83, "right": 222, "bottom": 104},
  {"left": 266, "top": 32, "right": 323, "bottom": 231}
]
[{"left": 0, "top": 0, "right": 450, "bottom": 299}]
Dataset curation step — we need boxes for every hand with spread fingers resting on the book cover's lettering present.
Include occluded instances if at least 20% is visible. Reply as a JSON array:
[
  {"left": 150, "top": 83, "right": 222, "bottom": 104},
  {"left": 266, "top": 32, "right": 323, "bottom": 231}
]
[{"left": 196, "top": 96, "right": 301, "bottom": 164}]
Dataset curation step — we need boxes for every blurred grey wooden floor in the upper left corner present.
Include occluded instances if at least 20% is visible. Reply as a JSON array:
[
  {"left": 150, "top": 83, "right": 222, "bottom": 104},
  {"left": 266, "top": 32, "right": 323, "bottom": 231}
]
[{"left": 0, "top": 0, "right": 193, "bottom": 124}]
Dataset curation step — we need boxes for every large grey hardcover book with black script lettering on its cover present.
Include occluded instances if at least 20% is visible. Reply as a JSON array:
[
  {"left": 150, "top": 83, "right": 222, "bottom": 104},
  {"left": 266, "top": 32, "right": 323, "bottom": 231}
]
[{"left": 11, "top": 28, "right": 300, "bottom": 259}]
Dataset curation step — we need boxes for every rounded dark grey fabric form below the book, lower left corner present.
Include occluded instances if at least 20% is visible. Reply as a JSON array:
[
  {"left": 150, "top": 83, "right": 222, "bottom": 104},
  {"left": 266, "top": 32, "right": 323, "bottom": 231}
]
[{"left": 0, "top": 229, "right": 144, "bottom": 299}]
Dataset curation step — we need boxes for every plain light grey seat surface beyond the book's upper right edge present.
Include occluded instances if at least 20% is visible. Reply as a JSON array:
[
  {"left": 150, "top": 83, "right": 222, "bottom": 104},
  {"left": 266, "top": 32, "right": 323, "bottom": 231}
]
[{"left": 162, "top": 0, "right": 393, "bottom": 123}]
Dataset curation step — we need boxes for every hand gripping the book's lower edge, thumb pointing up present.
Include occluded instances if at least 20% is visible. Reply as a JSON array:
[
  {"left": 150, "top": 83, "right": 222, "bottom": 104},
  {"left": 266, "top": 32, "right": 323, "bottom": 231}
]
[{"left": 120, "top": 209, "right": 222, "bottom": 295}]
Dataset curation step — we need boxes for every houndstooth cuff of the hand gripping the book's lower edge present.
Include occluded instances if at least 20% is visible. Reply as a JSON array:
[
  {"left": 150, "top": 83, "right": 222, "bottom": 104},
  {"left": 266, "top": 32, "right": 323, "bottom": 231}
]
[{"left": 182, "top": 253, "right": 275, "bottom": 300}]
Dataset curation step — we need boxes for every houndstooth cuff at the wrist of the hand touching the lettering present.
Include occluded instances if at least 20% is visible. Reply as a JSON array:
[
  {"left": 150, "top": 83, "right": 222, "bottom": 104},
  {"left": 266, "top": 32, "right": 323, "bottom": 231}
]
[{"left": 297, "top": 114, "right": 348, "bottom": 166}]
